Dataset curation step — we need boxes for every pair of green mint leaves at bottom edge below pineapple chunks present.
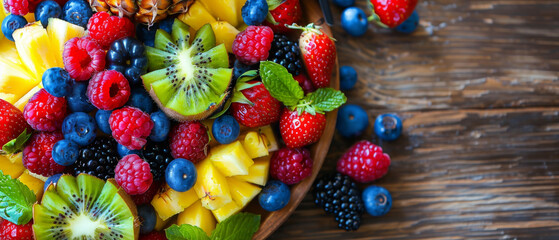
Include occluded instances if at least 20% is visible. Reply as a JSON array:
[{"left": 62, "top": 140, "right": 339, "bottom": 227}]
[{"left": 165, "top": 213, "right": 260, "bottom": 240}]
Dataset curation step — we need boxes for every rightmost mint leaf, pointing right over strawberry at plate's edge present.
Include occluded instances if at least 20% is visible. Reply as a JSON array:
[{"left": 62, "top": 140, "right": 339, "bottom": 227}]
[{"left": 303, "top": 88, "right": 347, "bottom": 113}]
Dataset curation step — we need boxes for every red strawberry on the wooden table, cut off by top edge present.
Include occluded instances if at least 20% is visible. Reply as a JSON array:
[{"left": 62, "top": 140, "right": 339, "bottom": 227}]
[{"left": 369, "top": 0, "right": 417, "bottom": 28}]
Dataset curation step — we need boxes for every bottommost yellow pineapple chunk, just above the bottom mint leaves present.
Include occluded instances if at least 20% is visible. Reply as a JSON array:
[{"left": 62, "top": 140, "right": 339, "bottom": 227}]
[{"left": 177, "top": 201, "right": 216, "bottom": 236}]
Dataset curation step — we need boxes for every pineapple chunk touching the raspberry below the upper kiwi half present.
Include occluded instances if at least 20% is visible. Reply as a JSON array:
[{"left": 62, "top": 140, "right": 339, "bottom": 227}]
[{"left": 208, "top": 141, "right": 254, "bottom": 177}]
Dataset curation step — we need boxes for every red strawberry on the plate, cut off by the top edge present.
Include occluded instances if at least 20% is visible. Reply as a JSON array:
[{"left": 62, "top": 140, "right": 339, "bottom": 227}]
[{"left": 264, "top": 0, "right": 303, "bottom": 33}]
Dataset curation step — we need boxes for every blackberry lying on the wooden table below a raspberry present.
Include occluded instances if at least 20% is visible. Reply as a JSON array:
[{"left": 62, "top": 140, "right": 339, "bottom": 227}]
[{"left": 312, "top": 173, "right": 365, "bottom": 231}]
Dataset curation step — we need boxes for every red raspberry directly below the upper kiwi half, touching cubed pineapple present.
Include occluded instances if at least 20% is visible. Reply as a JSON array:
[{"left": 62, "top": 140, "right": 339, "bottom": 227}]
[{"left": 169, "top": 121, "right": 210, "bottom": 163}]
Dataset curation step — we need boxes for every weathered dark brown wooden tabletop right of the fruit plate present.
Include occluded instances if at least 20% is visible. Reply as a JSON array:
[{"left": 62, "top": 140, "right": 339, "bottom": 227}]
[{"left": 271, "top": 0, "right": 559, "bottom": 240}]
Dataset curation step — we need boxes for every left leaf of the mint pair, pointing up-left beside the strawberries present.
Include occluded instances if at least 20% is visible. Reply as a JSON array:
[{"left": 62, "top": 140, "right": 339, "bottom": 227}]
[{"left": 260, "top": 61, "right": 305, "bottom": 107}]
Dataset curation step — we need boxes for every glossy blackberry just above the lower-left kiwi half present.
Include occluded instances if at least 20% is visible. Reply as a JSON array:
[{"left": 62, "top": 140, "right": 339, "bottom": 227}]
[{"left": 74, "top": 137, "right": 120, "bottom": 180}]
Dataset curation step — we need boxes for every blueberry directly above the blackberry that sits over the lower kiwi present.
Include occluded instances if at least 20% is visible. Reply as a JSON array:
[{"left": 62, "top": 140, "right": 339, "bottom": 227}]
[{"left": 62, "top": 112, "right": 97, "bottom": 146}]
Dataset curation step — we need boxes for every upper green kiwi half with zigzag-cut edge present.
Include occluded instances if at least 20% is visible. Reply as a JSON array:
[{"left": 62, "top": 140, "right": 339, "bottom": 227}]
[{"left": 142, "top": 19, "right": 233, "bottom": 122}]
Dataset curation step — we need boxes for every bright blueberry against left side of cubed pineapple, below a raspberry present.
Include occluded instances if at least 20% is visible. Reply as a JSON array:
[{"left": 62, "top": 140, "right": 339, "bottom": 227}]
[{"left": 165, "top": 158, "right": 197, "bottom": 192}]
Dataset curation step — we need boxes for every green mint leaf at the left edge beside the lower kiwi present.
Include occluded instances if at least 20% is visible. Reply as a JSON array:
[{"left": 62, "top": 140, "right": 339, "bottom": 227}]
[{"left": 0, "top": 170, "right": 36, "bottom": 225}]
